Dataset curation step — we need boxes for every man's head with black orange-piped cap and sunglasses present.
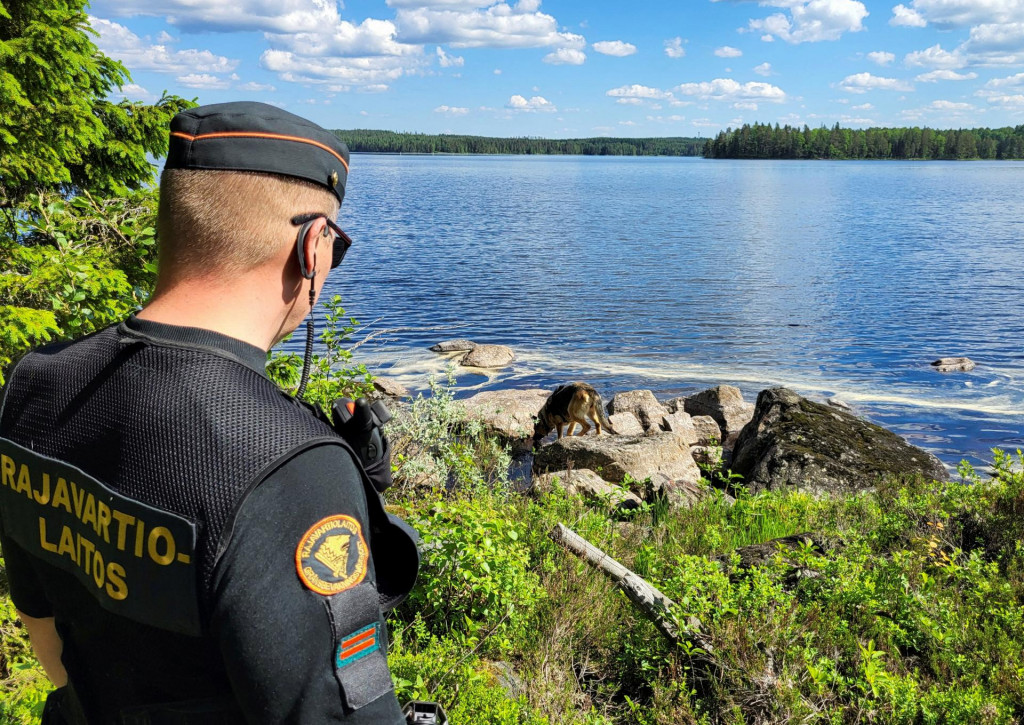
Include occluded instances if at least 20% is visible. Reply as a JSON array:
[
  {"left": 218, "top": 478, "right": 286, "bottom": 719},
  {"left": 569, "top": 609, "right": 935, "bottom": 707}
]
[{"left": 158, "top": 102, "right": 348, "bottom": 285}]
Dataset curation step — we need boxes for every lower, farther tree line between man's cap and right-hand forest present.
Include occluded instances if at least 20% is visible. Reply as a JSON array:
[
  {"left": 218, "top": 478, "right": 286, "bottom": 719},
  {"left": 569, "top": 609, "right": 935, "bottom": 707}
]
[{"left": 334, "top": 129, "right": 706, "bottom": 156}]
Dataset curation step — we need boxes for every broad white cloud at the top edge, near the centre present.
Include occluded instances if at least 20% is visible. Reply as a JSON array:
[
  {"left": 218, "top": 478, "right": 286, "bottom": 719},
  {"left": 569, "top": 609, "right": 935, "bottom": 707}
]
[{"left": 390, "top": 1, "right": 587, "bottom": 49}]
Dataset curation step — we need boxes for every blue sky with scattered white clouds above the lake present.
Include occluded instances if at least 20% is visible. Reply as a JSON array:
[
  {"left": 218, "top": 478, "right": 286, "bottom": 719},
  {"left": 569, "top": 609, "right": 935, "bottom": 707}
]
[{"left": 89, "top": 0, "right": 1024, "bottom": 138}]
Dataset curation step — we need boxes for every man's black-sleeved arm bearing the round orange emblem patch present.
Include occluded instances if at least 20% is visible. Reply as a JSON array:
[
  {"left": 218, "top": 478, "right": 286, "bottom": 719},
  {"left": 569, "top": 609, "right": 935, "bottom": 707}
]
[{"left": 211, "top": 444, "right": 404, "bottom": 724}]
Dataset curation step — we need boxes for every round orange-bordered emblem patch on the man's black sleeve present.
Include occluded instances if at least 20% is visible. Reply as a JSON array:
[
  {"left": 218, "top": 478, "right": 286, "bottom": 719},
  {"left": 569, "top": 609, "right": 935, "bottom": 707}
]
[{"left": 295, "top": 514, "right": 370, "bottom": 595}]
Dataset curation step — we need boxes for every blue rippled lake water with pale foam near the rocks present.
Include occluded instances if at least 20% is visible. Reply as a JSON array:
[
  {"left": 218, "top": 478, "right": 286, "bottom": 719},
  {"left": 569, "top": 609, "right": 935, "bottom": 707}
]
[{"left": 299, "top": 155, "right": 1024, "bottom": 465}]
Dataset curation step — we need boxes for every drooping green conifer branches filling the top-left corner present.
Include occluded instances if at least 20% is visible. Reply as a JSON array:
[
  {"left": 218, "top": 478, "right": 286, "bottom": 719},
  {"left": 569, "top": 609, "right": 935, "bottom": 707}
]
[{"left": 0, "top": 0, "right": 191, "bottom": 209}]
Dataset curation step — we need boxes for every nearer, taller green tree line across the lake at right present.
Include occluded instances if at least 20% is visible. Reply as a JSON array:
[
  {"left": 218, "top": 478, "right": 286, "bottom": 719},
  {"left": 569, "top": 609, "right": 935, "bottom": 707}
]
[{"left": 703, "top": 124, "right": 1024, "bottom": 160}]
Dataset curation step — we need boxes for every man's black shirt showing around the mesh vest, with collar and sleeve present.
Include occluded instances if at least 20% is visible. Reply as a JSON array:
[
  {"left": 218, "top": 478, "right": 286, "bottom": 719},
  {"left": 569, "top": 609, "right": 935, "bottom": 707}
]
[{"left": 0, "top": 318, "right": 404, "bottom": 723}]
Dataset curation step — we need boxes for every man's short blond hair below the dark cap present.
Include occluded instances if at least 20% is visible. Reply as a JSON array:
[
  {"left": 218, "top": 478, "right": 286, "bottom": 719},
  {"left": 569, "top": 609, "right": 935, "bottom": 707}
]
[{"left": 157, "top": 169, "right": 340, "bottom": 278}]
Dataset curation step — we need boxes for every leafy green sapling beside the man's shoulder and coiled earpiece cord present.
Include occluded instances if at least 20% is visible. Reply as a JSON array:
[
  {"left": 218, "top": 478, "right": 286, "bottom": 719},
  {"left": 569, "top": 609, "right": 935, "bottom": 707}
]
[{"left": 266, "top": 295, "right": 374, "bottom": 413}]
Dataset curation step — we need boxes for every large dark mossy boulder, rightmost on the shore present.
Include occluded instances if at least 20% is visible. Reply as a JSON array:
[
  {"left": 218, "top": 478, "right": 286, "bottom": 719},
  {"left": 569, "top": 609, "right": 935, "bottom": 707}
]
[{"left": 732, "top": 388, "right": 948, "bottom": 493}]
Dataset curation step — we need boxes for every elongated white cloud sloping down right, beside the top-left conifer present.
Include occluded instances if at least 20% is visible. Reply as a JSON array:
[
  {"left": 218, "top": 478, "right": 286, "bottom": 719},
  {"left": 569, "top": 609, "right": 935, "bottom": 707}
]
[{"left": 89, "top": 17, "right": 239, "bottom": 75}]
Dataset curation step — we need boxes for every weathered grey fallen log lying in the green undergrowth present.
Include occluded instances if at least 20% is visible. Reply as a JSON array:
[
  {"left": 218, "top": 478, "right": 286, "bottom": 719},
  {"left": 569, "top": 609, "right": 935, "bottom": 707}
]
[{"left": 549, "top": 523, "right": 719, "bottom": 673}]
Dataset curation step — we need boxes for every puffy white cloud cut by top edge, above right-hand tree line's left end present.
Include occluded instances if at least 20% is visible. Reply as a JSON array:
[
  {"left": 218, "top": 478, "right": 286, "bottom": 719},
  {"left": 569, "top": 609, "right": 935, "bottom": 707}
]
[{"left": 741, "top": 0, "right": 868, "bottom": 44}]
